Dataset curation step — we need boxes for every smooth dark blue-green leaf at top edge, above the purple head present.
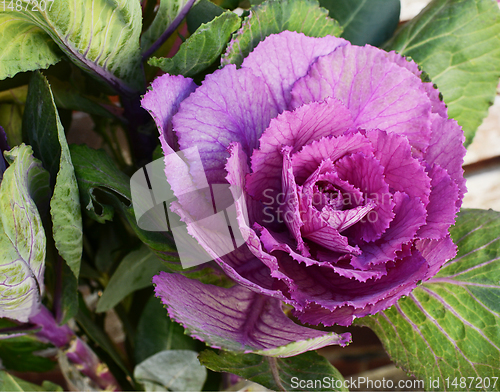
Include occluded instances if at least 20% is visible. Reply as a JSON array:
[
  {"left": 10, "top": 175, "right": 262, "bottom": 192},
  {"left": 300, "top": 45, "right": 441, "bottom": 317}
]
[{"left": 319, "top": 0, "right": 401, "bottom": 46}]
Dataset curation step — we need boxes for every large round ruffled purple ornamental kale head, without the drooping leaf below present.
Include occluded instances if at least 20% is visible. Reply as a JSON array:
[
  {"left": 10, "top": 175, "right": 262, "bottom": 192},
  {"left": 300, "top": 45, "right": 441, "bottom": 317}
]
[{"left": 143, "top": 31, "right": 465, "bottom": 326}]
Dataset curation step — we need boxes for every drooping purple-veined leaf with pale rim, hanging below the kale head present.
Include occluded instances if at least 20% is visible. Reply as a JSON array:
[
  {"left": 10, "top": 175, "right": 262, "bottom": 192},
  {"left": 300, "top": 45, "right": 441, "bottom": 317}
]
[{"left": 153, "top": 272, "right": 350, "bottom": 357}]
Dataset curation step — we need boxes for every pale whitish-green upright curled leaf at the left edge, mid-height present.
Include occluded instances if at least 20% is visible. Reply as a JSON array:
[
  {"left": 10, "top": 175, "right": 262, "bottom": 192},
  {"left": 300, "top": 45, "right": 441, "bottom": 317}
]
[{"left": 0, "top": 144, "right": 49, "bottom": 322}]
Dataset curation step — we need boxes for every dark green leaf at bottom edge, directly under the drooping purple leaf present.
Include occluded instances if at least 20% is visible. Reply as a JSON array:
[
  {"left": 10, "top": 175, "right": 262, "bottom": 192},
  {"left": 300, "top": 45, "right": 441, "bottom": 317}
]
[{"left": 199, "top": 350, "right": 348, "bottom": 391}]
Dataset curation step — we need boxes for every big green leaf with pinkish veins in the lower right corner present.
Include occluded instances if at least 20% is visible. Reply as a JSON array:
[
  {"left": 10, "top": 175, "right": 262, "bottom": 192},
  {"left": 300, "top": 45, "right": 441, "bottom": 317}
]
[{"left": 359, "top": 210, "right": 500, "bottom": 391}]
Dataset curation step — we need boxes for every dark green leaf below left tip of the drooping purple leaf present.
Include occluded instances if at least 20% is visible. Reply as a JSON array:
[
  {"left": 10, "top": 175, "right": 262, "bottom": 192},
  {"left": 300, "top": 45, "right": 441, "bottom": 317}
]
[{"left": 135, "top": 297, "right": 196, "bottom": 363}]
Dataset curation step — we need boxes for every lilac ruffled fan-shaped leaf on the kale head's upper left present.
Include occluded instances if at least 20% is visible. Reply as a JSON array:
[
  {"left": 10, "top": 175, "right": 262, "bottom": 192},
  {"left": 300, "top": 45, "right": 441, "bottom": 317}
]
[{"left": 172, "top": 65, "right": 277, "bottom": 183}]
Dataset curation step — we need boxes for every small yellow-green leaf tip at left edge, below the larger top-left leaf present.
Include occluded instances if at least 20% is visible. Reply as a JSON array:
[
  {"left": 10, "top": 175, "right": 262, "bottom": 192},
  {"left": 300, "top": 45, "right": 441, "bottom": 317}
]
[{"left": 0, "top": 14, "right": 61, "bottom": 80}]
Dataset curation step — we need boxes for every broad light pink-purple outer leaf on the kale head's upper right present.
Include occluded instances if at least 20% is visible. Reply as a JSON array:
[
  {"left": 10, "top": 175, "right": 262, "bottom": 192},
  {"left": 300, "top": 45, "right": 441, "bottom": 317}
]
[{"left": 292, "top": 46, "right": 431, "bottom": 151}]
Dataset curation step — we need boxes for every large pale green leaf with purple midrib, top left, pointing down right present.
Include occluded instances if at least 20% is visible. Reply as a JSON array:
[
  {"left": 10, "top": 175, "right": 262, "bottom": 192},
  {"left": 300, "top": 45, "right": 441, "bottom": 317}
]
[{"left": 0, "top": 0, "right": 144, "bottom": 94}]
